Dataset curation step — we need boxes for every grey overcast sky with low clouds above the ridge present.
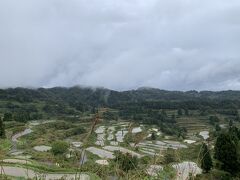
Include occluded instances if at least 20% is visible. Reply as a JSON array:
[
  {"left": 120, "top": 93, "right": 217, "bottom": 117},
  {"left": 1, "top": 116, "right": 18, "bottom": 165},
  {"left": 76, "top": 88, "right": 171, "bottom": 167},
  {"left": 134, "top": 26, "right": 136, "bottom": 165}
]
[{"left": 0, "top": 0, "right": 240, "bottom": 90}]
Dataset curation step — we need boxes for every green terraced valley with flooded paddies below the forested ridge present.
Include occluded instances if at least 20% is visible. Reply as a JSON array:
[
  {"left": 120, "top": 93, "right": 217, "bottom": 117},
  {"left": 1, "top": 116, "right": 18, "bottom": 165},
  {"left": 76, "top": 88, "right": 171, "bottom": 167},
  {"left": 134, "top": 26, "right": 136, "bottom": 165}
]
[{"left": 0, "top": 87, "right": 239, "bottom": 180}]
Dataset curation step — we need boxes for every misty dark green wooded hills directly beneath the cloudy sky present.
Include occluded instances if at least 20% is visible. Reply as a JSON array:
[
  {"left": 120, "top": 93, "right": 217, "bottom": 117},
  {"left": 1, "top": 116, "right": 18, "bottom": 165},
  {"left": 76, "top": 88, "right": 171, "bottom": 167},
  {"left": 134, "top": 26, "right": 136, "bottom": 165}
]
[{"left": 0, "top": 87, "right": 240, "bottom": 106}]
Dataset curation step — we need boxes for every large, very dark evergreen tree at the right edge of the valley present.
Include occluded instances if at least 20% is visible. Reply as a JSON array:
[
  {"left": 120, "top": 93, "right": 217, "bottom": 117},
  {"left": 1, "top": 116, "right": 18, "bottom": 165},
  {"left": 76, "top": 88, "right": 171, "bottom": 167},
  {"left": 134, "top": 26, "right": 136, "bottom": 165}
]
[{"left": 215, "top": 134, "right": 240, "bottom": 174}]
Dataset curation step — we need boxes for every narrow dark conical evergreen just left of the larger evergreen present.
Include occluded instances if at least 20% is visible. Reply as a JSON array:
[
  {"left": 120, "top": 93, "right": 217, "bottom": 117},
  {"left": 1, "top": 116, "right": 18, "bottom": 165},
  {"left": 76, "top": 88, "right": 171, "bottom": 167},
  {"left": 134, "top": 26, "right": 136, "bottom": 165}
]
[{"left": 201, "top": 143, "right": 213, "bottom": 173}]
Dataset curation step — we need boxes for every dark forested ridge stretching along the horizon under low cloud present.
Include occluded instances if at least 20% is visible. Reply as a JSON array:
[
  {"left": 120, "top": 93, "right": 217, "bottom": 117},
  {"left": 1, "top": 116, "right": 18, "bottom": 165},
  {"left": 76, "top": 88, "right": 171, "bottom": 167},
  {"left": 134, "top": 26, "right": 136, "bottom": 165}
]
[{"left": 0, "top": 87, "right": 240, "bottom": 109}]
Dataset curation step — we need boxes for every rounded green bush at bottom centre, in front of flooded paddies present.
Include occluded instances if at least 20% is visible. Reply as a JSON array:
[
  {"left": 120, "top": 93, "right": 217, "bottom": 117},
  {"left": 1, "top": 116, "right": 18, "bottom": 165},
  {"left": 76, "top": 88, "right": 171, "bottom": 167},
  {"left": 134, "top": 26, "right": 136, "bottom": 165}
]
[{"left": 114, "top": 151, "right": 138, "bottom": 172}]
